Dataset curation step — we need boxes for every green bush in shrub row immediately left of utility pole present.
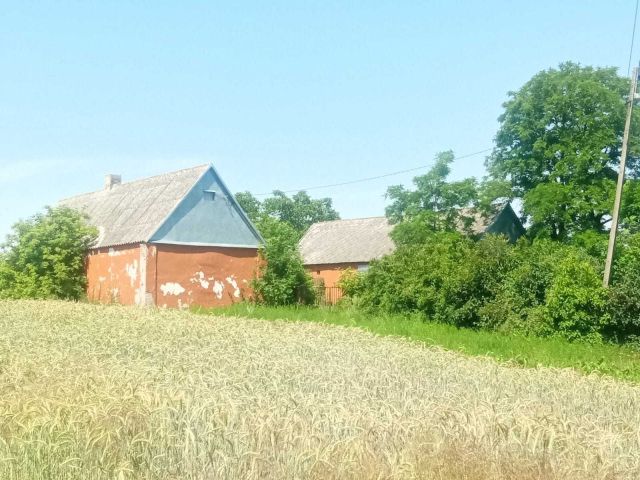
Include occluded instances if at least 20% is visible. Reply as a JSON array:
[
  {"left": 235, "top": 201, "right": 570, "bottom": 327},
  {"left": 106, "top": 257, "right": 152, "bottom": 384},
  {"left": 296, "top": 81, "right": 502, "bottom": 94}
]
[{"left": 480, "top": 240, "right": 609, "bottom": 341}]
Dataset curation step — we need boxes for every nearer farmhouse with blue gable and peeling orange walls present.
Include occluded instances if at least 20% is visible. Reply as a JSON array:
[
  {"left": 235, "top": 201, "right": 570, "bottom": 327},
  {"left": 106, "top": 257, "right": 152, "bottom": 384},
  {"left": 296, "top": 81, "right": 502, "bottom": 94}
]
[{"left": 60, "top": 165, "right": 262, "bottom": 307}]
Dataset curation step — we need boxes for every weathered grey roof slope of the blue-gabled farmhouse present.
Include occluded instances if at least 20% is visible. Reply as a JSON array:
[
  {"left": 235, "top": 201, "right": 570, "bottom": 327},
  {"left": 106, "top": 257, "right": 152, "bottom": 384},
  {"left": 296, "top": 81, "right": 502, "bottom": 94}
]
[{"left": 60, "top": 165, "right": 211, "bottom": 247}]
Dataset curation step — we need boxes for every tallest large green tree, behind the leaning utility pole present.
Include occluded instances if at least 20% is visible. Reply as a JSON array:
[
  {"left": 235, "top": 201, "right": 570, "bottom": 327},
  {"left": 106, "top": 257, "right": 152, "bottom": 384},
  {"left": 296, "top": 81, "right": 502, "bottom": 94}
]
[{"left": 487, "top": 62, "right": 638, "bottom": 240}]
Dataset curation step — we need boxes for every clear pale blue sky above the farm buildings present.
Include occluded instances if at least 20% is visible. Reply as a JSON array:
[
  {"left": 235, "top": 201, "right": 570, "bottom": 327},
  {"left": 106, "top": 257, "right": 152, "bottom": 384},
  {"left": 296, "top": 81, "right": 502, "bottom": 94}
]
[{"left": 0, "top": 0, "right": 640, "bottom": 238}]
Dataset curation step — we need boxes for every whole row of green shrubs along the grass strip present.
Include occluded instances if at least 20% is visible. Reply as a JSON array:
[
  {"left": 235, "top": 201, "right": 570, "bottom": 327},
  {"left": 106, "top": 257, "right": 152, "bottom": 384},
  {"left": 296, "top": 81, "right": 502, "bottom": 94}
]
[{"left": 343, "top": 233, "right": 640, "bottom": 342}]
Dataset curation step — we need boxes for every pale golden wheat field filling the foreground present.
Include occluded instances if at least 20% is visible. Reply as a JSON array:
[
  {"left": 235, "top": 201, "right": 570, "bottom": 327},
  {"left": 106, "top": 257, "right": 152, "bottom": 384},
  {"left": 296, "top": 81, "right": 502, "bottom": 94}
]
[{"left": 0, "top": 301, "right": 640, "bottom": 479}]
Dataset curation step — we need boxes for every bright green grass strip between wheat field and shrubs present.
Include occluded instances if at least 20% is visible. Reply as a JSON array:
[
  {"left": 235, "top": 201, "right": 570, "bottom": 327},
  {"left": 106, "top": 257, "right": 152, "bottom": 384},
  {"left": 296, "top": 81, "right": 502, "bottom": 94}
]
[{"left": 193, "top": 303, "right": 640, "bottom": 383}]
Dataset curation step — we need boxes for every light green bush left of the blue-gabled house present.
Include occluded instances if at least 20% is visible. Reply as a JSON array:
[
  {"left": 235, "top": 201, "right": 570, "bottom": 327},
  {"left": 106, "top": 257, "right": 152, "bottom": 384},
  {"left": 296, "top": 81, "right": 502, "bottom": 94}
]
[{"left": 0, "top": 207, "right": 97, "bottom": 300}]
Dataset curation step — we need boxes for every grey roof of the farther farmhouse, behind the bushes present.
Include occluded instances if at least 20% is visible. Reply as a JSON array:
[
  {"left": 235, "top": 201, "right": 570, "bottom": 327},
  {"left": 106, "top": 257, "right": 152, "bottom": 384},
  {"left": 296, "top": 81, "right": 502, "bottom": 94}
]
[{"left": 299, "top": 217, "right": 394, "bottom": 265}]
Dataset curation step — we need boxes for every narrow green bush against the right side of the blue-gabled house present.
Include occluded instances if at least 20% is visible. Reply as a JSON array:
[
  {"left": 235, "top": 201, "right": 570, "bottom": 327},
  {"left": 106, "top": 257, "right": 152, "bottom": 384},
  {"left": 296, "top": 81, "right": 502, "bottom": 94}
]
[{"left": 253, "top": 217, "right": 315, "bottom": 306}]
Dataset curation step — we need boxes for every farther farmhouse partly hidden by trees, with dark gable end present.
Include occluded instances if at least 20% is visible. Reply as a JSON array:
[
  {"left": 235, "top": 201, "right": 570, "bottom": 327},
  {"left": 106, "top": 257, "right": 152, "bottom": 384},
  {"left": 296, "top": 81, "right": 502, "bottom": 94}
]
[{"left": 299, "top": 203, "right": 525, "bottom": 301}]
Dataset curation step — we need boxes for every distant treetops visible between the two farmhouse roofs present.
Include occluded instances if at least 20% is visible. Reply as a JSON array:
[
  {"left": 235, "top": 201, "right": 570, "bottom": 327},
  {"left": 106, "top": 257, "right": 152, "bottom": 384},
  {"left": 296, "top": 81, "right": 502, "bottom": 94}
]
[{"left": 236, "top": 190, "right": 340, "bottom": 236}]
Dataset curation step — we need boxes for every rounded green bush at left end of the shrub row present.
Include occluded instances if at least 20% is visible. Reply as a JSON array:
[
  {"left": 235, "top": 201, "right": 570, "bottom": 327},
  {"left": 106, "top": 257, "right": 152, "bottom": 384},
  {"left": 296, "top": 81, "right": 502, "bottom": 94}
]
[{"left": 359, "top": 232, "right": 512, "bottom": 326}]
